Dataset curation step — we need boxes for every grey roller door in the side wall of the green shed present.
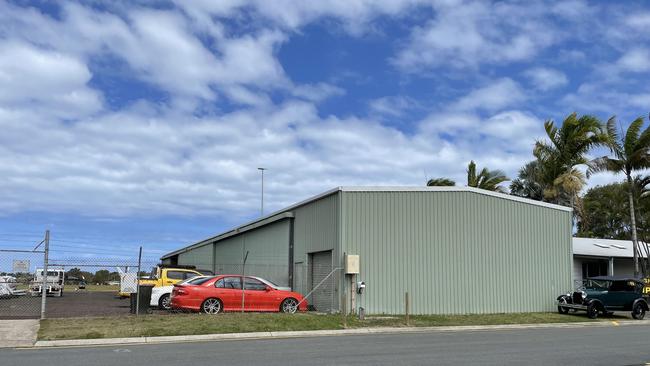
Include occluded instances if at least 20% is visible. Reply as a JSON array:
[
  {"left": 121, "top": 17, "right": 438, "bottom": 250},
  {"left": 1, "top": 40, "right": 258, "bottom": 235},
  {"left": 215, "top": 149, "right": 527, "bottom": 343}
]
[{"left": 308, "top": 250, "right": 334, "bottom": 312}]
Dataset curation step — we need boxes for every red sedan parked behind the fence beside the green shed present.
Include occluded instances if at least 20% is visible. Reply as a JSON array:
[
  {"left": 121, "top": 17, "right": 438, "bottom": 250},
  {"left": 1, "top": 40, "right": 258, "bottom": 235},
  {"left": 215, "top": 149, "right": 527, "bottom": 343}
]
[{"left": 171, "top": 275, "right": 307, "bottom": 314}]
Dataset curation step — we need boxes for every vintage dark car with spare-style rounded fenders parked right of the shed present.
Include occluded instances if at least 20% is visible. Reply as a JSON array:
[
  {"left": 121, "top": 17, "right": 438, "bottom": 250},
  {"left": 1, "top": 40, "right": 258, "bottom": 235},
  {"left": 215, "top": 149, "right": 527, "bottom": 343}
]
[{"left": 557, "top": 276, "right": 650, "bottom": 320}]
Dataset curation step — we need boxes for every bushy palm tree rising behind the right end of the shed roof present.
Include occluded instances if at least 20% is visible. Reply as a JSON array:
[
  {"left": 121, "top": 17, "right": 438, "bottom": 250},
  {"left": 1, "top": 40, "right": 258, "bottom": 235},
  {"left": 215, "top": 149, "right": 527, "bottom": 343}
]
[{"left": 533, "top": 113, "right": 608, "bottom": 203}]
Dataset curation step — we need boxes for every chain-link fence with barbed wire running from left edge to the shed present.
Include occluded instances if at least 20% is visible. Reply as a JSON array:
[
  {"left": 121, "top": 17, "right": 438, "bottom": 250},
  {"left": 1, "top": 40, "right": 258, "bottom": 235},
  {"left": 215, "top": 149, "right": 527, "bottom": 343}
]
[{"left": 0, "top": 234, "right": 342, "bottom": 319}]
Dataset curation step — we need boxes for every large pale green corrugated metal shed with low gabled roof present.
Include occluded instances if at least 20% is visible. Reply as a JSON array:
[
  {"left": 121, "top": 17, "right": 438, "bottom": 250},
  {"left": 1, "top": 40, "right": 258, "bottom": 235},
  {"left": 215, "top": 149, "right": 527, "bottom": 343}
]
[{"left": 162, "top": 187, "right": 572, "bottom": 314}]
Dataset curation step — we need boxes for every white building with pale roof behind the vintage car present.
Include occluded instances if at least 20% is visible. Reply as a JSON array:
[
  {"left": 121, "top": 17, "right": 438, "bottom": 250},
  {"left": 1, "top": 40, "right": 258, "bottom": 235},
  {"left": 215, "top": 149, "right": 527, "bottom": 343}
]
[{"left": 573, "top": 238, "right": 634, "bottom": 283}]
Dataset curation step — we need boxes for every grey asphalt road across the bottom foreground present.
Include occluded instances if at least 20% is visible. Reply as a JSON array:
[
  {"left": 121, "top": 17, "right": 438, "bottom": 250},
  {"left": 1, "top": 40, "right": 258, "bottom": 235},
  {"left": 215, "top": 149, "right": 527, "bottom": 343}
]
[{"left": 0, "top": 326, "right": 650, "bottom": 366}]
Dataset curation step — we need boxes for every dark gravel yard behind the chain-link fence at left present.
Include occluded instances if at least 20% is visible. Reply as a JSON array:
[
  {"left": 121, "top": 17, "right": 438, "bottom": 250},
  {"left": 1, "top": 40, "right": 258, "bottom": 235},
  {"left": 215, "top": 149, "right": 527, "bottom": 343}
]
[{"left": 0, "top": 292, "right": 163, "bottom": 319}]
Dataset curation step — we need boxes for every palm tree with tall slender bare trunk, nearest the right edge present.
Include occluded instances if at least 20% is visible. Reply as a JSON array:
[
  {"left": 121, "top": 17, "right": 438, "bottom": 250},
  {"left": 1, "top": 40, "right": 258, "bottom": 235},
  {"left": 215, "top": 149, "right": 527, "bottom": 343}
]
[{"left": 587, "top": 117, "right": 650, "bottom": 276}]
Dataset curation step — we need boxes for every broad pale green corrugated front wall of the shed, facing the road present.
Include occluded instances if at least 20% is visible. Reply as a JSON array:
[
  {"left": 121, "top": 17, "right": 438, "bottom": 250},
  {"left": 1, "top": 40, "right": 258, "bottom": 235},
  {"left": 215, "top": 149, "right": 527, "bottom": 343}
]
[{"left": 342, "top": 192, "right": 571, "bottom": 314}]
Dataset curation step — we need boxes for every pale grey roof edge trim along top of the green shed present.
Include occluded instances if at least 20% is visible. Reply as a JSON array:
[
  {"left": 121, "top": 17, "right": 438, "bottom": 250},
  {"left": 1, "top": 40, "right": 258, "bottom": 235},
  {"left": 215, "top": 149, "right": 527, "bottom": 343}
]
[{"left": 161, "top": 186, "right": 572, "bottom": 259}]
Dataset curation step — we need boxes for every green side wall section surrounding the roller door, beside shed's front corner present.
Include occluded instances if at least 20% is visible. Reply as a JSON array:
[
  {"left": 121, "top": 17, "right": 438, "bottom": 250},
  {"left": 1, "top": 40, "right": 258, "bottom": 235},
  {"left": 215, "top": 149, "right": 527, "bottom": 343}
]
[{"left": 293, "top": 193, "right": 340, "bottom": 308}]
